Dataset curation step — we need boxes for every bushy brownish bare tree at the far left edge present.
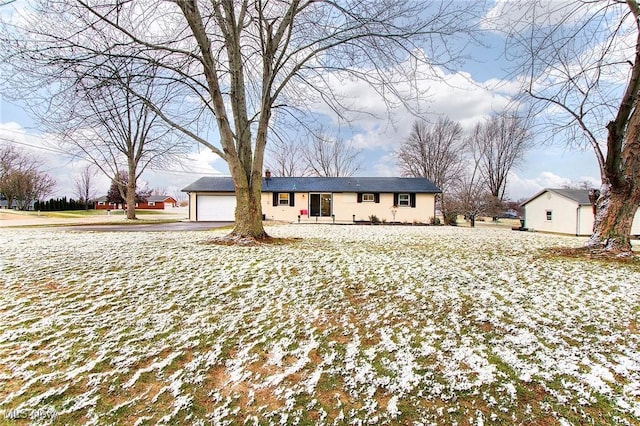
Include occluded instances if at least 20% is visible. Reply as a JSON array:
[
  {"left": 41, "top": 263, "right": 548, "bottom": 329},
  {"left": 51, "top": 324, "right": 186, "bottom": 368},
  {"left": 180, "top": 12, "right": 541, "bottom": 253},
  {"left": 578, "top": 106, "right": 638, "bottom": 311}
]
[{"left": 0, "top": 144, "right": 55, "bottom": 210}]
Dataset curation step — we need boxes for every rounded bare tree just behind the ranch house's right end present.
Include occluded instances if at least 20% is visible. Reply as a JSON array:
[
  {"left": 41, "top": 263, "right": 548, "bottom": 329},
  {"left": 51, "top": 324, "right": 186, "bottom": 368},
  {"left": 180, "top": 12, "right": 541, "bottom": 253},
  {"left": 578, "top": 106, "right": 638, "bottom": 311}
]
[{"left": 396, "top": 117, "right": 465, "bottom": 215}]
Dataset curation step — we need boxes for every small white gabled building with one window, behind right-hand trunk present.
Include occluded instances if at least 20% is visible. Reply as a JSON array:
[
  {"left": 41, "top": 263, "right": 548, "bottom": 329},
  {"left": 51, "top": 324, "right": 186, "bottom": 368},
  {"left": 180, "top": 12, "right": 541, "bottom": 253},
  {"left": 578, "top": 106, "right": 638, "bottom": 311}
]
[{"left": 522, "top": 188, "right": 640, "bottom": 235}]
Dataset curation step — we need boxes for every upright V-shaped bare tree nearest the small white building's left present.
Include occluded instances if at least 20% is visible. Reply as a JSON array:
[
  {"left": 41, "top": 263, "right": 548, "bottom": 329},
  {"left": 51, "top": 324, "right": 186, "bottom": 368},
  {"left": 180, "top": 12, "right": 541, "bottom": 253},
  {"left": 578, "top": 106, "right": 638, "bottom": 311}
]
[{"left": 474, "top": 113, "right": 532, "bottom": 202}]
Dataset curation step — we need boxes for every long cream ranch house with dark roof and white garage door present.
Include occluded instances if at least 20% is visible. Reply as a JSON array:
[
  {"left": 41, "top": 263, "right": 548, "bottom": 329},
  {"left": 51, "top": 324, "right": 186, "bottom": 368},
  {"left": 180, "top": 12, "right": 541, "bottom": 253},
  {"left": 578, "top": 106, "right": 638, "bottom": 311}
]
[{"left": 183, "top": 173, "right": 442, "bottom": 223}]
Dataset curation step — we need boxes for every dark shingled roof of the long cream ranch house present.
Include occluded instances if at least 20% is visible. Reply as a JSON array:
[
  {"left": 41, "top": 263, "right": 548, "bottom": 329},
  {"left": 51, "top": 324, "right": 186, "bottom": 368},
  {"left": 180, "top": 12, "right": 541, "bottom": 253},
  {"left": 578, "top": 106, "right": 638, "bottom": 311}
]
[{"left": 182, "top": 177, "right": 442, "bottom": 194}]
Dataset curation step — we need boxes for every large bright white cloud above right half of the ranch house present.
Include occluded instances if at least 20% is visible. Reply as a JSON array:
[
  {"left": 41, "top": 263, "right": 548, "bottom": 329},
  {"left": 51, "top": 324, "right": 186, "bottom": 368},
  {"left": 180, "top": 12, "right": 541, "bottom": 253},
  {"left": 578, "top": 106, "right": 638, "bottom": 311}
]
[{"left": 307, "top": 54, "right": 520, "bottom": 151}]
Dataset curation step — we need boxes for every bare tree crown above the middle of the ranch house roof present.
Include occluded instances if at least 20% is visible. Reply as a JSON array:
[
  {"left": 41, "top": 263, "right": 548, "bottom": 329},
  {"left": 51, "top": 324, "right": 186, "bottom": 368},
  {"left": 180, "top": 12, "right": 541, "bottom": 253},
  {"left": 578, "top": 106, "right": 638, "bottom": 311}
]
[{"left": 302, "top": 133, "right": 362, "bottom": 177}]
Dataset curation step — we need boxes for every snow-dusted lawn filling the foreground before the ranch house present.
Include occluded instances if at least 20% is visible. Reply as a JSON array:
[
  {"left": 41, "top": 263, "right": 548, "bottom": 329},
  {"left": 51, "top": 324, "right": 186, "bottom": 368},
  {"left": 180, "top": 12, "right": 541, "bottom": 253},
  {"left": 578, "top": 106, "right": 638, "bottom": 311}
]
[{"left": 0, "top": 225, "right": 640, "bottom": 425}]
